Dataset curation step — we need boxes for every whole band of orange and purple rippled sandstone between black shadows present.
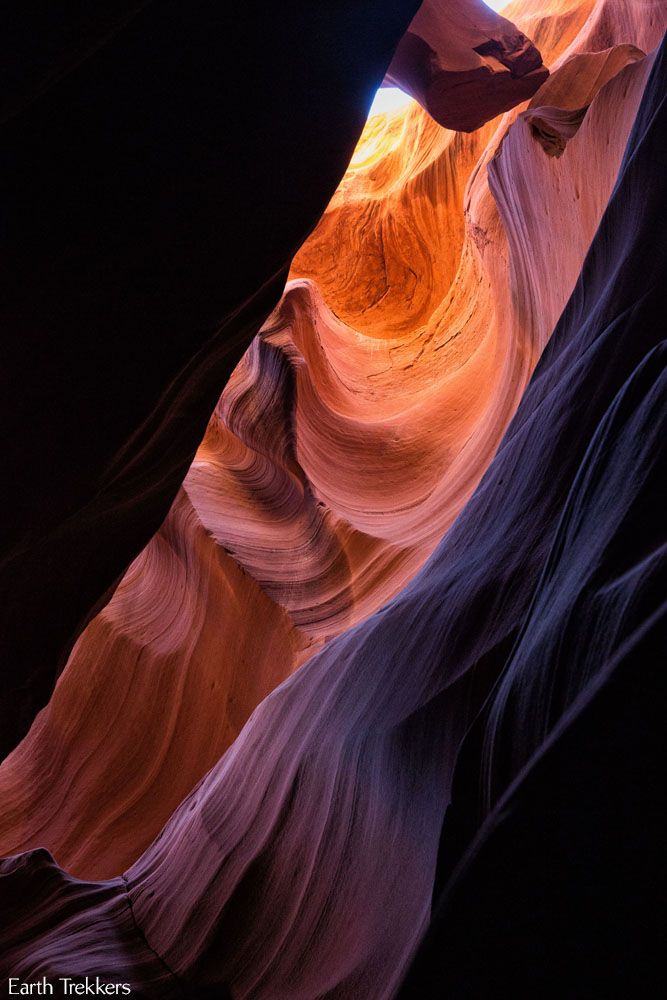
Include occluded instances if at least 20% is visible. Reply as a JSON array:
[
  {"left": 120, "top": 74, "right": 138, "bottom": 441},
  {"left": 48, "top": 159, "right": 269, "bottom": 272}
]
[{"left": 0, "top": 0, "right": 667, "bottom": 1000}]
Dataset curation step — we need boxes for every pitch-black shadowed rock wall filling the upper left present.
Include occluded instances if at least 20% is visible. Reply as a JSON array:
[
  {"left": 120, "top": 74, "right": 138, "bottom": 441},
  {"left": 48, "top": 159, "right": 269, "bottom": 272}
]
[{"left": 0, "top": 0, "right": 418, "bottom": 753}]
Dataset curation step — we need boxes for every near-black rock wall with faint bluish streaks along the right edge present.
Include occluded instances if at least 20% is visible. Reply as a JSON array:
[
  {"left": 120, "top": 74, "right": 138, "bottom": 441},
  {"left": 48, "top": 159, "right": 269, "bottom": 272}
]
[{"left": 399, "top": 33, "right": 667, "bottom": 998}]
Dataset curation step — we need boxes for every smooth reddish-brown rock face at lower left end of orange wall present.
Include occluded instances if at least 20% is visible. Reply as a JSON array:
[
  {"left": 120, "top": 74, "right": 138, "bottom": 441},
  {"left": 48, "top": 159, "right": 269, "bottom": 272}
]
[{"left": 0, "top": 493, "right": 306, "bottom": 877}]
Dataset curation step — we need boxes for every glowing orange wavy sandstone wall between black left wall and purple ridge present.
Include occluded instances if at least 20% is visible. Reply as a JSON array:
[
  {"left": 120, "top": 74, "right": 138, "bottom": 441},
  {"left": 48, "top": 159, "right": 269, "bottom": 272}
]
[{"left": 0, "top": 0, "right": 664, "bottom": 878}]
